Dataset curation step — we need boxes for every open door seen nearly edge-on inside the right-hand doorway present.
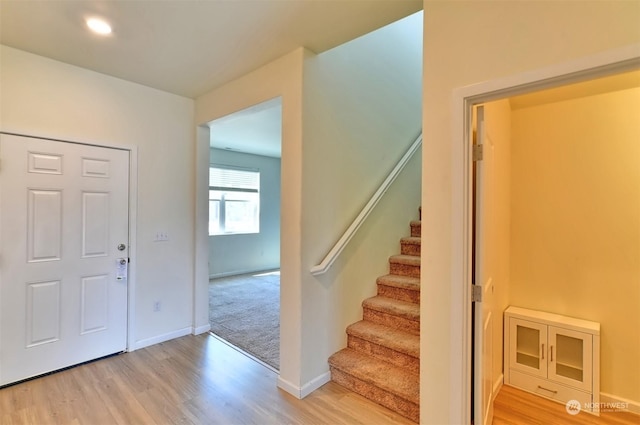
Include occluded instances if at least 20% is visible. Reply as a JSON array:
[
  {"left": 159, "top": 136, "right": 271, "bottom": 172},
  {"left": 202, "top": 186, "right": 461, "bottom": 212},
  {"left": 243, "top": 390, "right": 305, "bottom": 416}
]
[{"left": 473, "top": 106, "right": 497, "bottom": 425}]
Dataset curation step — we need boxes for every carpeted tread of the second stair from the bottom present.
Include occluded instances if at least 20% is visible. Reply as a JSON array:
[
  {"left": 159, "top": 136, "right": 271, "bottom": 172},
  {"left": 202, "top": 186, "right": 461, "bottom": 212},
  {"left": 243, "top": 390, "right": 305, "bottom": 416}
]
[{"left": 347, "top": 320, "right": 420, "bottom": 358}]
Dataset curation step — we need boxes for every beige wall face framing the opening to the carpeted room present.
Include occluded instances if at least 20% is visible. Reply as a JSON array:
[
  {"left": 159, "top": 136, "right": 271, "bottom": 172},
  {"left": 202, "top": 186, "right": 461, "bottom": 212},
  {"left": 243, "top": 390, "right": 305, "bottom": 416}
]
[{"left": 196, "top": 48, "right": 312, "bottom": 394}]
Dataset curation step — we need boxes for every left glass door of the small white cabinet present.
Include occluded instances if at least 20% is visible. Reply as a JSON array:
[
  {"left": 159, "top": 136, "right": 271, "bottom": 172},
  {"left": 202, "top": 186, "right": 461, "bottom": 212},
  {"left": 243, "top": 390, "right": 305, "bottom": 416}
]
[{"left": 509, "top": 318, "right": 547, "bottom": 377}]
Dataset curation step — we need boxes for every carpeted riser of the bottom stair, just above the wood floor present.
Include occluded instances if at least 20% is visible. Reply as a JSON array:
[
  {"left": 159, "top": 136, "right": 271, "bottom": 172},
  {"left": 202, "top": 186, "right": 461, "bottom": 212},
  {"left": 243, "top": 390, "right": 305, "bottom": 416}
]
[{"left": 331, "top": 367, "right": 420, "bottom": 423}]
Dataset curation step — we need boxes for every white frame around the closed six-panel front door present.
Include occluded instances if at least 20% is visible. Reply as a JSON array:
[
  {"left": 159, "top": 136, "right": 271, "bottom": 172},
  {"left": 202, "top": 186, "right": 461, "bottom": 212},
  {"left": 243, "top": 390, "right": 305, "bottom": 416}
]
[{"left": 0, "top": 131, "right": 138, "bottom": 351}]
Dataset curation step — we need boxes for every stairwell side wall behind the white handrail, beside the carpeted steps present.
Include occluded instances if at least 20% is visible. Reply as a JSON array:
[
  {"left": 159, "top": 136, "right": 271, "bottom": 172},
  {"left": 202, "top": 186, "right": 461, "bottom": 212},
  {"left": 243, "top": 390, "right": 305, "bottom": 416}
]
[{"left": 301, "top": 9, "right": 427, "bottom": 380}]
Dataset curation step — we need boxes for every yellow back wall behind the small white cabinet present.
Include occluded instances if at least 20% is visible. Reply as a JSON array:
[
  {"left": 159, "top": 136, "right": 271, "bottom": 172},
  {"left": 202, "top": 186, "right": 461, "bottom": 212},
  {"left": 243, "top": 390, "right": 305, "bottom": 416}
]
[{"left": 510, "top": 88, "right": 640, "bottom": 402}]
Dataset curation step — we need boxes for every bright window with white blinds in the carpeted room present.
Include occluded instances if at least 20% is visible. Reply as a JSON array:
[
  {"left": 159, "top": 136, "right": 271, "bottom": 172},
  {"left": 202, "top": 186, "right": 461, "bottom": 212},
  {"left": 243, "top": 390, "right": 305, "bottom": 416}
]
[{"left": 209, "top": 165, "right": 260, "bottom": 235}]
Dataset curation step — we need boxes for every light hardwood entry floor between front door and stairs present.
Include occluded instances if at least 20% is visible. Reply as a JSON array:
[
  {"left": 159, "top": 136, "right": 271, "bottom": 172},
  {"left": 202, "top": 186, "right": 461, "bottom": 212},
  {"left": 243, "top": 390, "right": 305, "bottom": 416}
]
[{"left": 0, "top": 334, "right": 412, "bottom": 425}]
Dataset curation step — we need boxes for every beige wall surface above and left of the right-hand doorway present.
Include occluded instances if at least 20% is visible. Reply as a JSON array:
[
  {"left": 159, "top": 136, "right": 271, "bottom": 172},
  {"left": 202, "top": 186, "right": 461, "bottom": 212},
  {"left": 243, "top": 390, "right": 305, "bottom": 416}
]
[{"left": 420, "top": 0, "right": 640, "bottom": 424}]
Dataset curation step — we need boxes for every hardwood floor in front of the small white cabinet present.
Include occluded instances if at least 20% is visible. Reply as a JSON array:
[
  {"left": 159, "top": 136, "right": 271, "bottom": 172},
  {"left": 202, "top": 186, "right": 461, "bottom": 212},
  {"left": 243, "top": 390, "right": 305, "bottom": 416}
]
[{"left": 493, "top": 385, "right": 640, "bottom": 425}]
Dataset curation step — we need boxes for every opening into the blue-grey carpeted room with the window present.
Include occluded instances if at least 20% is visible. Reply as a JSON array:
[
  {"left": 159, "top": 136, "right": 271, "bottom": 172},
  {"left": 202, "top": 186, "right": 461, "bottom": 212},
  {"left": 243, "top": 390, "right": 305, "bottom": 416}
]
[{"left": 208, "top": 97, "right": 282, "bottom": 371}]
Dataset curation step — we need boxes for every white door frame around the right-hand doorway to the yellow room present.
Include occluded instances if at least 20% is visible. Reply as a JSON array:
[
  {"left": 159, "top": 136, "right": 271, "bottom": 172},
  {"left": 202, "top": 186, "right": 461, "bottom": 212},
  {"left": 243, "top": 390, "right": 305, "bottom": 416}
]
[{"left": 449, "top": 44, "right": 640, "bottom": 424}]
